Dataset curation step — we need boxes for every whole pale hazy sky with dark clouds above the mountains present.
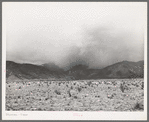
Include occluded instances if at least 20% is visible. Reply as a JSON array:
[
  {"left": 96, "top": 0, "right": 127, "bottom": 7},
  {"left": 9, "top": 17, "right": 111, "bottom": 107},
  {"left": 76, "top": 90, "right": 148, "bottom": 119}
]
[{"left": 3, "top": 2, "right": 147, "bottom": 68}]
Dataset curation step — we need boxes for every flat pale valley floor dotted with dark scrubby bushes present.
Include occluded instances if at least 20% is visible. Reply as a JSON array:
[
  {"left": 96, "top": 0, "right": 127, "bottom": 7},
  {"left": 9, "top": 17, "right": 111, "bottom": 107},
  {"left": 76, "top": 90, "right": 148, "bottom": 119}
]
[{"left": 5, "top": 79, "right": 144, "bottom": 112}]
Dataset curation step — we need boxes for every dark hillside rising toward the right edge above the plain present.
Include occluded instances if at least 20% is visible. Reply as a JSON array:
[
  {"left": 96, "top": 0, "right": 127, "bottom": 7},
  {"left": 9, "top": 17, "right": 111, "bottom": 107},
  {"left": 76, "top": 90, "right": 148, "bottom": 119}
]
[{"left": 89, "top": 61, "right": 144, "bottom": 78}]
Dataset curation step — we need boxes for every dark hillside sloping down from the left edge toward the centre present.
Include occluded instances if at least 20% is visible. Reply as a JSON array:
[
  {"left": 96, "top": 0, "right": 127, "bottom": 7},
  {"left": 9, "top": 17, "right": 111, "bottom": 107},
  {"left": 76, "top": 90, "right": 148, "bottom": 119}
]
[{"left": 6, "top": 61, "right": 72, "bottom": 79}]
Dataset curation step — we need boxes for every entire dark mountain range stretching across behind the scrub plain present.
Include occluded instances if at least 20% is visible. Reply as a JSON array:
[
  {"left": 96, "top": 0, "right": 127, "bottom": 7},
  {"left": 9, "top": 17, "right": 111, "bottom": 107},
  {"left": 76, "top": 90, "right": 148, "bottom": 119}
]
[{"left": 6, "top": 61, "right": 144, "bottom": 80}]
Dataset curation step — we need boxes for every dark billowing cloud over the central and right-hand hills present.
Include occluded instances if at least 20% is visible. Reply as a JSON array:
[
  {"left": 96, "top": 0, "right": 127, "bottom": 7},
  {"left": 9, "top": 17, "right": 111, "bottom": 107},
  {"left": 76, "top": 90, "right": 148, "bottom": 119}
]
[{"left": 56, "top": 27, "right": 144, "bottom": 68}]
